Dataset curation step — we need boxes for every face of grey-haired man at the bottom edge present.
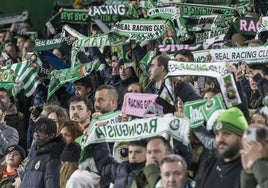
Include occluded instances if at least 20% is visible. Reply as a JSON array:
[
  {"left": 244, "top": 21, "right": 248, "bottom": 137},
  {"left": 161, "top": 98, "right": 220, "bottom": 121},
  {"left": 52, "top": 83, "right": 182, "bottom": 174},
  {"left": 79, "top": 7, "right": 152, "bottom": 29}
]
[{"left": 161, "top": 162, "right": 187, "bottom": 188}]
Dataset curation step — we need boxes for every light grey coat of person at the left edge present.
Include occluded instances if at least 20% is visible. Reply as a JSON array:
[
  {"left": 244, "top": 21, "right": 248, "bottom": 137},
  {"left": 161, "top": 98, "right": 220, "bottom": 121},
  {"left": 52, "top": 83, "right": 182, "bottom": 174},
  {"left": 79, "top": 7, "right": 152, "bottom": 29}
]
[{"left": 0, "top": 121, "right": 19, "bottom": 159}]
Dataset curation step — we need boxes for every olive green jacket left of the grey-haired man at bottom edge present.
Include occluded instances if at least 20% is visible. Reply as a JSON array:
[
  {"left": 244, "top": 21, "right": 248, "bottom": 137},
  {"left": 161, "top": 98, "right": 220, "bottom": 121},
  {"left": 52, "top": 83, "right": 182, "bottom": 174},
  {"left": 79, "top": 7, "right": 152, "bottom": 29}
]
[{"left": 131, "top": 164, "right": 160, "bottom": 188}]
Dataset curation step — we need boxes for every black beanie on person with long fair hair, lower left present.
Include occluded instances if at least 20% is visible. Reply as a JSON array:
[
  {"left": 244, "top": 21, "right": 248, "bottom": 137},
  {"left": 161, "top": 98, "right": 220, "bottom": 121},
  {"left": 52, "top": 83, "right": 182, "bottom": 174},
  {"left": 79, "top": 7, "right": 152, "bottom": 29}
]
[{"left": 60, "top": 142, "right": 81, "bottom": 162}]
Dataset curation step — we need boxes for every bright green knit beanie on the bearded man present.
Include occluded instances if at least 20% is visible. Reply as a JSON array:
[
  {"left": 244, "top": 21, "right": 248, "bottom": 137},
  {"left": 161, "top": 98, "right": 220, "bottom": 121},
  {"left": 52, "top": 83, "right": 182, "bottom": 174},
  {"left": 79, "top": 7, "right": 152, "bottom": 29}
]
[{"left": 214, "top": 107, "right": 248, "bottom": 136}]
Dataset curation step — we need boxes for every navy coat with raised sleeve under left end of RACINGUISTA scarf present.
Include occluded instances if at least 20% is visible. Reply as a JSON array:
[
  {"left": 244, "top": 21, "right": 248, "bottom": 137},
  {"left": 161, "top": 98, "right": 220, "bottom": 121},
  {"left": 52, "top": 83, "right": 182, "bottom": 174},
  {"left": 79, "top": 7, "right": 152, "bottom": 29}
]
[{"left": 93, "top": 143, "right": 145, "bottom": 188}]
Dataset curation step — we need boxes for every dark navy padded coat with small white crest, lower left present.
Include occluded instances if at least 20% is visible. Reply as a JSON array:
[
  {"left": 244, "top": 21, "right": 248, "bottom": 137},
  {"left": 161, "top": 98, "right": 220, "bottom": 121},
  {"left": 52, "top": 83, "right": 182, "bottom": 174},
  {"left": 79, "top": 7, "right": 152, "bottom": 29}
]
[{"left": 21, "top": 136, "right": 65, "bottom": 188}]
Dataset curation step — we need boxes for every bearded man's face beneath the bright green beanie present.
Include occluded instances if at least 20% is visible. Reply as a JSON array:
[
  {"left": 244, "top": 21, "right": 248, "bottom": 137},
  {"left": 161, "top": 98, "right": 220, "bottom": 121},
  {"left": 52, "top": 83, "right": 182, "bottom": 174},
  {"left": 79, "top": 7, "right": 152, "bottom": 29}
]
[{"left": 216, "top": 130, "right": 241, "bottom": 159}]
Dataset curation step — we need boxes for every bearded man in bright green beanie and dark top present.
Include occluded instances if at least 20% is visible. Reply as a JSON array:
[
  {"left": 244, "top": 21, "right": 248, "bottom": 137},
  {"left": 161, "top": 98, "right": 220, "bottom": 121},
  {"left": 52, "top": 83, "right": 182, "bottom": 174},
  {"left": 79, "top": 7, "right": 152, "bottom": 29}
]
[{"left": 196, "top": 107, "right": 248, "bottom": 188}]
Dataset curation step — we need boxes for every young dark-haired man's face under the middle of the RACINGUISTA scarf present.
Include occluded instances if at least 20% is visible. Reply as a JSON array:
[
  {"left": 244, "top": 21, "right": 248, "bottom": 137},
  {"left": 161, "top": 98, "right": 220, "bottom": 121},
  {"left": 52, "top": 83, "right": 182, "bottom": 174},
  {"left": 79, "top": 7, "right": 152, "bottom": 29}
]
[{"left": 128, "top": 145, "right": 146, "bottom": 163}]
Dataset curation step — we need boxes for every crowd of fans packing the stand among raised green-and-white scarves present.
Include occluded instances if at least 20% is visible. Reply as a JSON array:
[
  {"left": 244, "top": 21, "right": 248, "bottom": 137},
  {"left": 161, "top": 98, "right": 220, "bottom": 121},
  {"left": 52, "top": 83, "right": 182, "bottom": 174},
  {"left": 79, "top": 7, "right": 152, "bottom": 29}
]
[{"left": 0, "top": 0, "right": 268, "bottom": 188}]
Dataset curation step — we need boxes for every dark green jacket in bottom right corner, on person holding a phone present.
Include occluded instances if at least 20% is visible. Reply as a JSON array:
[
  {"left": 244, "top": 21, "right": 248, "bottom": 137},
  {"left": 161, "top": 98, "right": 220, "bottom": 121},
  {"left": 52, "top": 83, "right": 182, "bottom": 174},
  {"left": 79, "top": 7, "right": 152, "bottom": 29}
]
[{"left": 240, "top": 159, "right": 268, "bottom": 188}]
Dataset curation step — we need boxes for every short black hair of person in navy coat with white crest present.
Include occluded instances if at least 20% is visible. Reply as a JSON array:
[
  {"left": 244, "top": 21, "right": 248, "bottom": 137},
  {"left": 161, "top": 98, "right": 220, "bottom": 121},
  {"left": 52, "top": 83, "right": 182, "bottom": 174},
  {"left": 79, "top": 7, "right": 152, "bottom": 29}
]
[{"left": 34, "top": 117, "right": 57, "bottom": 136}]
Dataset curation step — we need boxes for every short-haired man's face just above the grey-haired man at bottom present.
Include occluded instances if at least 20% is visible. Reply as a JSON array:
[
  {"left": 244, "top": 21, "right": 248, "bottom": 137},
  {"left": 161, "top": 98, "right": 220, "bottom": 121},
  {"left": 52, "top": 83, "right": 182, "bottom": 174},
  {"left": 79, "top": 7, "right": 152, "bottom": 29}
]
[{"left": 146, "top": 138, "right": 168, "bottom": 164}]
